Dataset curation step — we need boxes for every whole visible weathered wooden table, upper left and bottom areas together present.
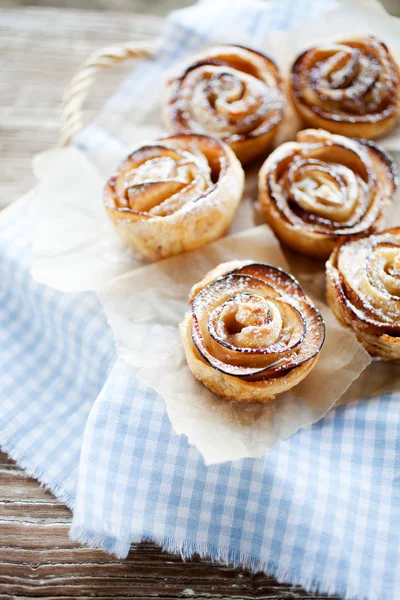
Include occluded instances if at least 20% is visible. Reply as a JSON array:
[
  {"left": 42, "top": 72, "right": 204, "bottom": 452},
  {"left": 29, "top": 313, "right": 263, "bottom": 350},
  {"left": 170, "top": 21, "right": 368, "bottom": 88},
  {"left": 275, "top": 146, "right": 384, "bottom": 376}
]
[{"left": 0, "top": 8, "right": 338, "bottom": 600}]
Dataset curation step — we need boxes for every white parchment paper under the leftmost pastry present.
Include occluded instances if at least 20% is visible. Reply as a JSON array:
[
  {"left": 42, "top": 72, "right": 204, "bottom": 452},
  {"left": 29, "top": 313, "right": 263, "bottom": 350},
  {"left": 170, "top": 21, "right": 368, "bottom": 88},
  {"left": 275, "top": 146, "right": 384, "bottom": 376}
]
[{"left": 31, "top": 127, "right": 162, "bottom": 292}]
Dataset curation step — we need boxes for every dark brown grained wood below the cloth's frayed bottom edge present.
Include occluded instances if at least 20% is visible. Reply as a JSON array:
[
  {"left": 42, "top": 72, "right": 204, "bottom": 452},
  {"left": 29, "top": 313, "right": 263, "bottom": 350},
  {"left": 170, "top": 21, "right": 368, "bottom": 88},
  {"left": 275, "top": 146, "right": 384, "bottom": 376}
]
[{"left": 0, "top": 453, "right": 336, "bottom": 600}]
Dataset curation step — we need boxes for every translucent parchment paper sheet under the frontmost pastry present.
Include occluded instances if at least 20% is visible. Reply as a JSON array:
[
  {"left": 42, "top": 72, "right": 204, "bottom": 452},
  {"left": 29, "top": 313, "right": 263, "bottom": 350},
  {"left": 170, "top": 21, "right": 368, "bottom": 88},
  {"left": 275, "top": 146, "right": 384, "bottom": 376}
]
[{"left": 100, "top": 225, "right": 370, "bottom": 464}]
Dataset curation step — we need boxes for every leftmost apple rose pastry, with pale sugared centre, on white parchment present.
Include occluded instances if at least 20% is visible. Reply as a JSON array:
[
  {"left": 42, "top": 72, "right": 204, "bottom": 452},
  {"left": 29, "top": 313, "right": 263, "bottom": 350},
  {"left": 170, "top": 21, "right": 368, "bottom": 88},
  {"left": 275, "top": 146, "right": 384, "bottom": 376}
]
[{"left": 104, "top": 134, "right": 244, "bottom": 260}]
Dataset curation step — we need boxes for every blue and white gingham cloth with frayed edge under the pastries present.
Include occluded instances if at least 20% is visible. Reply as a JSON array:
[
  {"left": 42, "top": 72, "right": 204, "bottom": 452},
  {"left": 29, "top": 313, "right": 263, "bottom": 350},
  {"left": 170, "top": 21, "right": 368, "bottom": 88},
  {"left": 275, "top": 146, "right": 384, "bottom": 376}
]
[{"left": 0, "top": 0, "right": 400, "bottom": 600}]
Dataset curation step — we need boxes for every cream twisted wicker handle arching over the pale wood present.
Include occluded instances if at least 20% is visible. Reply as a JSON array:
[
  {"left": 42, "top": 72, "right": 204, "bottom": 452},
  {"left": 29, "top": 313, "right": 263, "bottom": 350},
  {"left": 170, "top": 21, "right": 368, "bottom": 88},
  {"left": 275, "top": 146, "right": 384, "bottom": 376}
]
[{"left": 60, "top": 42, "right": 155, "bottom": 146}]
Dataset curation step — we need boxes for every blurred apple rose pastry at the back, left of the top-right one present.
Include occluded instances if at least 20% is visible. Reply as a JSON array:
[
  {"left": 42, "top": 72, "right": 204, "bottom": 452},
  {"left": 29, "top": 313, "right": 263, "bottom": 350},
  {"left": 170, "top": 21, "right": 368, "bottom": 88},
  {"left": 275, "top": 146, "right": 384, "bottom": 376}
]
[{"left": 164, "top": 46, "right": 285, "bottom": 162}]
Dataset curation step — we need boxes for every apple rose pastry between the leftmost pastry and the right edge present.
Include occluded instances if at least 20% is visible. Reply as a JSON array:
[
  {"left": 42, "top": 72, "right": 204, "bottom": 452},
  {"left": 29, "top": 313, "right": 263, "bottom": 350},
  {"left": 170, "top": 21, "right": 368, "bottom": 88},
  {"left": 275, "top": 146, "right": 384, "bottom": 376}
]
[{"left": 259, "top": 129, "right": 396, "bottom": 259}]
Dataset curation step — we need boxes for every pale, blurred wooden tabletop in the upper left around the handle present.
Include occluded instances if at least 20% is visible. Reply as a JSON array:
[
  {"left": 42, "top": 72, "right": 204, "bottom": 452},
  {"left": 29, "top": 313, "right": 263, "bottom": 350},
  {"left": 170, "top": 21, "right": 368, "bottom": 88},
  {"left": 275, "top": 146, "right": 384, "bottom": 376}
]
[{"left": 0, "top": 8, "right": 162, "bottom": 207}]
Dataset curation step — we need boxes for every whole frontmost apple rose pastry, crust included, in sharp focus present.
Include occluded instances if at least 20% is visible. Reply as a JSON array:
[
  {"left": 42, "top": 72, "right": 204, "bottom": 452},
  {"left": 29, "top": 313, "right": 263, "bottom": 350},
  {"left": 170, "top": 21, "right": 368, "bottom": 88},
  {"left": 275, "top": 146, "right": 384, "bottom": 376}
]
[{"left": 180, "top": 261, "right": 325, "bottom": 402}]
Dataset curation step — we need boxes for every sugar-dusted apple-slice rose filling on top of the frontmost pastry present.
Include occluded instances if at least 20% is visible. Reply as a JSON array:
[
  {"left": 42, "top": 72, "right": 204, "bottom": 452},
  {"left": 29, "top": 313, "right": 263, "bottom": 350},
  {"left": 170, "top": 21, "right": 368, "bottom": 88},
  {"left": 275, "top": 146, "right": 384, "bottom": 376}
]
[{"left": 192, "top": 263, "right": 324, "bottom": 379}]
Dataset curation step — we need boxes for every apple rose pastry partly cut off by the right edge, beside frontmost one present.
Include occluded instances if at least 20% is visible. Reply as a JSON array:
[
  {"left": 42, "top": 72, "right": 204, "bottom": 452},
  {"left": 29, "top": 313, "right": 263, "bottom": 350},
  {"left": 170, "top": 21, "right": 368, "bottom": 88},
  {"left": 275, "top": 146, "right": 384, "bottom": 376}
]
[{"left": 326, "top": 227, "right": 400, "bottom": 360}]
